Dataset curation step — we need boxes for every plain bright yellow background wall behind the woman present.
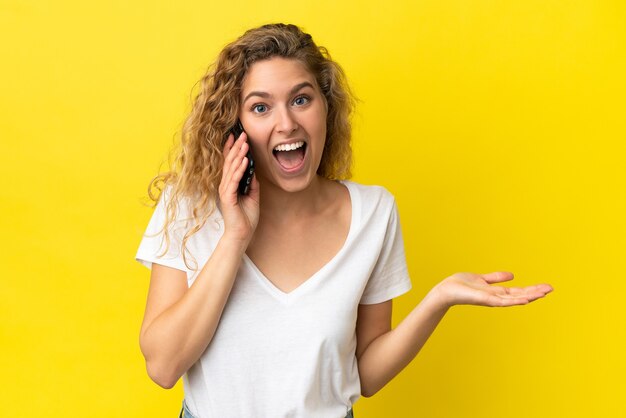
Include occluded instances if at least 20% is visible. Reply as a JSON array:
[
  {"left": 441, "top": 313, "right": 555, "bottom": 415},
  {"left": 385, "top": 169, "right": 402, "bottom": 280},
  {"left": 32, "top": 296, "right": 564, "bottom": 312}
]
[{"left": 0, "top": 0, "right": 626, "bottom": 418}]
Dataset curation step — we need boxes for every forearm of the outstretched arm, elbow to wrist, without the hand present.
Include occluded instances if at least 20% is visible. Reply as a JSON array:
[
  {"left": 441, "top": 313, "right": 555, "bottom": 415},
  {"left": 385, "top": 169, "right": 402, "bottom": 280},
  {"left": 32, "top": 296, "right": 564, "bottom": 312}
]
[{"left": 358, "top": 288, "right": 448, "bottom": 397}]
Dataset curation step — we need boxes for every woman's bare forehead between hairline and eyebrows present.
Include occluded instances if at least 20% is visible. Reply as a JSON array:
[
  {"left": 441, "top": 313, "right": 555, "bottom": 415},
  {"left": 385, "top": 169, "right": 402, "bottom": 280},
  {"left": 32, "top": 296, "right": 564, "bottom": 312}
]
[{"left": 241, "top": 57, "right": 317, "bottom": 96}]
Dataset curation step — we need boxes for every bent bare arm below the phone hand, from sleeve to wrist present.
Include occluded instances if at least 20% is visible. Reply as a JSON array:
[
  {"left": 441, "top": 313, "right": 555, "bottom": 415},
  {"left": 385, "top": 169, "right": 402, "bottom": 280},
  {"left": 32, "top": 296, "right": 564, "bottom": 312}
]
[{"left": 139, "top": 235, "right": 245, "bottom": 389}]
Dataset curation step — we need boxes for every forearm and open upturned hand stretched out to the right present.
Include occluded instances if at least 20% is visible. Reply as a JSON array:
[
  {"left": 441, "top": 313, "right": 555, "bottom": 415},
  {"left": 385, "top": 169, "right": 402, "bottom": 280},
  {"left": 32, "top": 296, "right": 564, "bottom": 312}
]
[{"left": 357, "top": 272, "right": 552, "bottom": 397}]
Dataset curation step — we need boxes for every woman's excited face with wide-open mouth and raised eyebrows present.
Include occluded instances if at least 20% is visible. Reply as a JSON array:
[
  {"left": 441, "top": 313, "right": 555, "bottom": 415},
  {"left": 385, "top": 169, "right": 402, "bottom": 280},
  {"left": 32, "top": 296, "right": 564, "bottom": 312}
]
[{"left": 239, "top": 57, "right": 327, "bottom": 192}]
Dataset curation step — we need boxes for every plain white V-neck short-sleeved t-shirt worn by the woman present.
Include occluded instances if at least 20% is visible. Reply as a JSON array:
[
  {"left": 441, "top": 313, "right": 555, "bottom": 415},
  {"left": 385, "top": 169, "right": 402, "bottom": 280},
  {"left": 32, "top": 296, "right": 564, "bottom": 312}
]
[{"left": 136, "top": 181, "right": 411, "bottom": 418}]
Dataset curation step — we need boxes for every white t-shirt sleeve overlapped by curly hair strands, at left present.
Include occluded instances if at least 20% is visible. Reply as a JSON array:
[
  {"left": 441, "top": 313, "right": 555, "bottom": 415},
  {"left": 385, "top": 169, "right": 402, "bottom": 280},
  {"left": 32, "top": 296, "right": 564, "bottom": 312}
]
[{"left": 135, "top": 188, "right": 189, "bottom": 272}]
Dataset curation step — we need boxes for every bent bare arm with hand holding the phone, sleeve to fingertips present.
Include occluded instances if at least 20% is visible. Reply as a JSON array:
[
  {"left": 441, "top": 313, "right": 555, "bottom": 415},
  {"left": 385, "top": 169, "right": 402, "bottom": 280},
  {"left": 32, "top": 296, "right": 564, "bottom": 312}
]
[{"left": 139, "top": 134, "right": 259, "bottom": 389}]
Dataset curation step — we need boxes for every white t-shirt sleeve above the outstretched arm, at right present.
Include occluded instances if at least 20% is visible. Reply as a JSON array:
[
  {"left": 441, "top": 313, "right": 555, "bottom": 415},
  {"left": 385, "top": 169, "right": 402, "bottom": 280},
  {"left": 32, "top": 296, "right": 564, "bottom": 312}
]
[{"left": 359, "top": 201, "right": 411, "bottom": 305}]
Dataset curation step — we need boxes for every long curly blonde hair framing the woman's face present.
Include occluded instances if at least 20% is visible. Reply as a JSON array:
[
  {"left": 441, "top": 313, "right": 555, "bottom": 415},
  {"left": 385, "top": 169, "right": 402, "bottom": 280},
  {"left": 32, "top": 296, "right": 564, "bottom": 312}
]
[{"left": 148, "top": 23, "right": 355, "bottom": 268}]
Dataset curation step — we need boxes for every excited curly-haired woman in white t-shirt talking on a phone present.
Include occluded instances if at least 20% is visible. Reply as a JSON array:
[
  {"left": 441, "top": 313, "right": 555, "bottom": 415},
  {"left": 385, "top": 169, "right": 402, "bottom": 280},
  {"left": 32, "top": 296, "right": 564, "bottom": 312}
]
[{"left": 137, "top": 24, "right": 552, "bottom": 418}]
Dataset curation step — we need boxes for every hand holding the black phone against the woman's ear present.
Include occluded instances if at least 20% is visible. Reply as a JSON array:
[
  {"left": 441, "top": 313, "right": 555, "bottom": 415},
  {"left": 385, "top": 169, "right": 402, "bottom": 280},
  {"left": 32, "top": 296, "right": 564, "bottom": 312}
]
[{"left": 219, "top": 132, "right": 260, "bottom": 246}]
